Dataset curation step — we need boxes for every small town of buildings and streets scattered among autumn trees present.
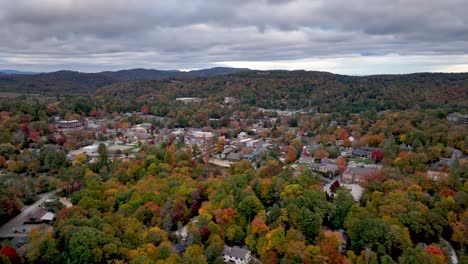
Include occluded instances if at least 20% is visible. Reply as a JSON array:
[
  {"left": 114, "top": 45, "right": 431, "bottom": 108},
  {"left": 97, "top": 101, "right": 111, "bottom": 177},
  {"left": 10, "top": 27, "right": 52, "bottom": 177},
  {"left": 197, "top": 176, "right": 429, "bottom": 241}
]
[{"left": 0, "top": 92, "right": 468, "bottom": 263}]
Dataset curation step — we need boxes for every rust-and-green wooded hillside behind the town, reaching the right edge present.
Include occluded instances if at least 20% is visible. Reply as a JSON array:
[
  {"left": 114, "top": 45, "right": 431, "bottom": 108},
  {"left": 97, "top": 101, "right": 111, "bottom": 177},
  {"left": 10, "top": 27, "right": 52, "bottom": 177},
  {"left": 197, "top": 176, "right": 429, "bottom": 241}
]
[{"left": 97, "top": 71, "right": 468, "bottom": 113}]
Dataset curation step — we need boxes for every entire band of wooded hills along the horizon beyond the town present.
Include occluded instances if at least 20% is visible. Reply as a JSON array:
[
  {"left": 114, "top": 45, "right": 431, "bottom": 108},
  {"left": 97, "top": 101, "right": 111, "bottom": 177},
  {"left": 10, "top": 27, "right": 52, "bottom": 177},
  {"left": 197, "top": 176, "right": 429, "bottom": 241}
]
[{"left": 0, "top": 67, "right": 468, "bottom": 111}]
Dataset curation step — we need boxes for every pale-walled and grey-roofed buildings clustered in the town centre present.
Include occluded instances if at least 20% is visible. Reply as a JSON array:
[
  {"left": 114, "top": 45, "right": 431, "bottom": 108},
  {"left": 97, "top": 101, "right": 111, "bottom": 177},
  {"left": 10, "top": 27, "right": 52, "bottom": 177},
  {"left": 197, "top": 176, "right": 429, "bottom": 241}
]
[{"left": 55, "top": 106, "right": 467, "bottom": 196}]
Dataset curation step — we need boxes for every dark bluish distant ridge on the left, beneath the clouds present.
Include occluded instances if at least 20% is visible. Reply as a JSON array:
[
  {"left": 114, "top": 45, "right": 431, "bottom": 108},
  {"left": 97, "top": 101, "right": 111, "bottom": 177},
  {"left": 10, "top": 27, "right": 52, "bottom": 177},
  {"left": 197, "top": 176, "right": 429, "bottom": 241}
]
[{"left": 0, "top": 67, "right": 249, "bottom": 94}]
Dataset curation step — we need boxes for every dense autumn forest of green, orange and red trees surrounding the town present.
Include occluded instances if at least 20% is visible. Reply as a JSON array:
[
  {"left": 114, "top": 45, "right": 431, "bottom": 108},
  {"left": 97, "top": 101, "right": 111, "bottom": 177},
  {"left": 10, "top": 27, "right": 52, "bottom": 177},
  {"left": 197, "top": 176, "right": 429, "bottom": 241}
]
[{"left": 0, "top": 71, "right": 468, "bottom": 264}]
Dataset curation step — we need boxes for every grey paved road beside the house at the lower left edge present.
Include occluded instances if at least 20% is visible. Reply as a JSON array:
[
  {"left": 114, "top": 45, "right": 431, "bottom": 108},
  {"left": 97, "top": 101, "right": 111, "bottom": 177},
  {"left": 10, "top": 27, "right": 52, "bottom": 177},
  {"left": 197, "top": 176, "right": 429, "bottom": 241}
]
[{"left": 0, "top": 191, "right": 55, "bottom": 238}]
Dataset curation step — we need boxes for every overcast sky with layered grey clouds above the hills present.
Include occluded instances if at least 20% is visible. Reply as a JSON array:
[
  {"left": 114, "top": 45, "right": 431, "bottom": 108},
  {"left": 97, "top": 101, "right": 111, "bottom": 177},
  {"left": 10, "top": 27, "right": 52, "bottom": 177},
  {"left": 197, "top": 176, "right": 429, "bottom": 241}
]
[{"left": 0, "top": 0, "right": 468, "bottom": 75}]
